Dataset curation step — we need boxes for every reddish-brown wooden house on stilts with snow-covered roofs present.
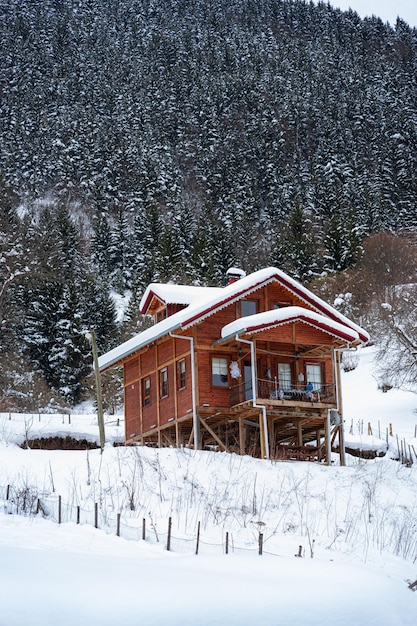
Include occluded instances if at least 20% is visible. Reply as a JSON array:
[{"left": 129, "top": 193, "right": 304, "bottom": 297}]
[{"left": 99, "top": 267, "right": 369, "bottom": 463}]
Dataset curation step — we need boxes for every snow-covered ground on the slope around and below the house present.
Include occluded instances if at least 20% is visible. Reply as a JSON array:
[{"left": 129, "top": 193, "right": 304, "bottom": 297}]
[{"left": 0, "top": 348, "right": 417, "bottom": 626}]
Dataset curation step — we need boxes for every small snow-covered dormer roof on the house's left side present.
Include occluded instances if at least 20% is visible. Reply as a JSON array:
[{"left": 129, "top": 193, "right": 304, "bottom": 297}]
[{"left": 139, "top": 283, "right": 223, "bottom": 313}]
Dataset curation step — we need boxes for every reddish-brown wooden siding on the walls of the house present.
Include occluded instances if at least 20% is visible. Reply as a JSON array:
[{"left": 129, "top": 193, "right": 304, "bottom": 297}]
[{"left": 124, "top": 283, "right": 346, "bottom": 454}]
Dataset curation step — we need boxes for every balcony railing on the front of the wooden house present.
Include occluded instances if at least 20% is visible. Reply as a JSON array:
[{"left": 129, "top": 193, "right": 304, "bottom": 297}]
[{"left": 230, "top": 378, "right": 336, "bottom": 405}]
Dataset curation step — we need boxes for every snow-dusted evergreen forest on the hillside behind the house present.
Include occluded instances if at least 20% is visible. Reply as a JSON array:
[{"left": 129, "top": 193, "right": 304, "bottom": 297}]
[{"left": 0, "top": 0, "right": 417, "bottom": 410}]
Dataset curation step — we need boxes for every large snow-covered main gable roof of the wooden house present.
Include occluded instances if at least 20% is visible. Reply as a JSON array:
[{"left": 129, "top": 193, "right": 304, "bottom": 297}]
[{"left": 99, "top": 267, "right": 369, "bottom": 370}]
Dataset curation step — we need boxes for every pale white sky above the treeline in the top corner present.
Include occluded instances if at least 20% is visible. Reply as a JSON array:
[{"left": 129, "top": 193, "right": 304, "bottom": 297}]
[{"left": 324, "top": 0, "right": 417, "bottom": 28}]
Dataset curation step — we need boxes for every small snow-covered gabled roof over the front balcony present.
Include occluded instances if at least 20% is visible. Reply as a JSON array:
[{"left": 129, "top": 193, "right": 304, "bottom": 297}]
[{"left": 221, "top": 306, "right": 359, "bottom": 343}]
